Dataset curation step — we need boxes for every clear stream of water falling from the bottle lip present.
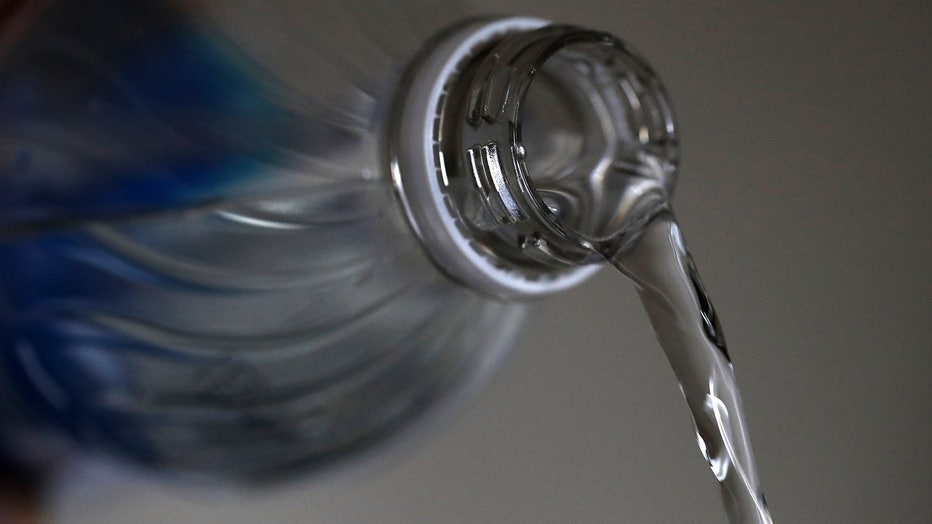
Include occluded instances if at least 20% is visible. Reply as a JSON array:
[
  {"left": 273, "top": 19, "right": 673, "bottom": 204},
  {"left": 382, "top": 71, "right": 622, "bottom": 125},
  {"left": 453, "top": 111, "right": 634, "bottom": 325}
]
[{"left": 605, "top": 212, "right": 772, "bottom": 524}]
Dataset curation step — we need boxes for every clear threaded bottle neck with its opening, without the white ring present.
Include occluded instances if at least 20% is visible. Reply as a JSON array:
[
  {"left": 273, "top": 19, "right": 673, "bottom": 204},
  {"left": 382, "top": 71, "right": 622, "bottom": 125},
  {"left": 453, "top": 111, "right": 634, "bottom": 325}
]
[{"left": 441, "top": 26, "right": 677, "bottom": 269}]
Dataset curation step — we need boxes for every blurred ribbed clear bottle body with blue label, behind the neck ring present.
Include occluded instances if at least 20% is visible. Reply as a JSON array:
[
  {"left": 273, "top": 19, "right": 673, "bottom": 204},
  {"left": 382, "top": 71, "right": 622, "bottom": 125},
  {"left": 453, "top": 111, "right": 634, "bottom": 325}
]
[{"left": 0, "top": 0, "right": 524, "bottom": 478}]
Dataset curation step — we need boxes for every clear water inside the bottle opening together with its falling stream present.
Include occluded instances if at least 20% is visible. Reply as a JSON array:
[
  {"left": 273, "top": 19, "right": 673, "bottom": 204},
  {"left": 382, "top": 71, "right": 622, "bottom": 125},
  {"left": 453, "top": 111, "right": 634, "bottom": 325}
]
[{"left": 506, "top": 30, "right": 771, "bottom": 524}]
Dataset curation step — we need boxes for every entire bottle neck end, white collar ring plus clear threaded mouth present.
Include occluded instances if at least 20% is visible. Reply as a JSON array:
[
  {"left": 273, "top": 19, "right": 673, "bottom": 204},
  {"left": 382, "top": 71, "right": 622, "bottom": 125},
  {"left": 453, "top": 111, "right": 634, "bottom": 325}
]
[{"left": 392, "top": 18, "right": 678, "bottom": 296}]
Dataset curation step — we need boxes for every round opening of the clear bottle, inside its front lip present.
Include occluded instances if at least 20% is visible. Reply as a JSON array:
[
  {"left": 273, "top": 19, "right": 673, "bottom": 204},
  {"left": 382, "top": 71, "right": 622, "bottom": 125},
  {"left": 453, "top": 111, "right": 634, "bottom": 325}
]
[{"left": 516, "top": 37, "right": 676, "bottom": 248}]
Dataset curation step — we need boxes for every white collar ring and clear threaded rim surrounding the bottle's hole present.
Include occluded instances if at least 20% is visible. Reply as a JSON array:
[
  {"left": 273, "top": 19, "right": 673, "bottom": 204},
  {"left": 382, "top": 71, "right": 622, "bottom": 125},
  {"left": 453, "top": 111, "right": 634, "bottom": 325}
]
[{"left": 388, "top": 17, "right": 678, "bottom": 298}]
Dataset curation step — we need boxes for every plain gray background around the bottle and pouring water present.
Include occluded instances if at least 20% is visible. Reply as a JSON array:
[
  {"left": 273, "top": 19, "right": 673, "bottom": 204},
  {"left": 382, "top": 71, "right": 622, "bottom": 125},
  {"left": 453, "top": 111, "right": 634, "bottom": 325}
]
[{"left": 52, "top": 0, "right": 932, "bottom": 524}]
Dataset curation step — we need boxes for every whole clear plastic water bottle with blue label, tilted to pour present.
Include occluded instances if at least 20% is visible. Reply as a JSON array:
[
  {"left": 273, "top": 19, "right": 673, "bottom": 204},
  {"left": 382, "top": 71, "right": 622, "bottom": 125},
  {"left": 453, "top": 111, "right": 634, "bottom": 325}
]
[{"left": 0, "top": 0, "right": 676, "bottom": 480}]
